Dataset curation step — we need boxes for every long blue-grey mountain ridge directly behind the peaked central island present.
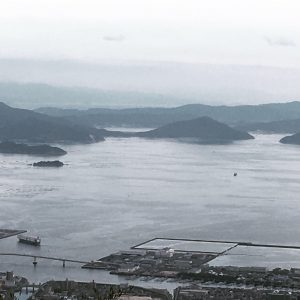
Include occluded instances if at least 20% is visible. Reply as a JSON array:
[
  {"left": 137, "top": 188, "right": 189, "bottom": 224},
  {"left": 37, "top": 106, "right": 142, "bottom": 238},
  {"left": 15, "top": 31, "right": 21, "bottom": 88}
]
[{"left": 36, "top": 101, "right": 300, "bottom": 128}]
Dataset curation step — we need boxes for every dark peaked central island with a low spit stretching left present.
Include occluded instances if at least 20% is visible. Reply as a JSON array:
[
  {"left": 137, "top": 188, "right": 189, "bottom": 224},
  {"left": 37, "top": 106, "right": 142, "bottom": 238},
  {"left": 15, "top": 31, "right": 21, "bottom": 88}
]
[{"left": 101, "top": 117, "right": 254, "bottom": 144}]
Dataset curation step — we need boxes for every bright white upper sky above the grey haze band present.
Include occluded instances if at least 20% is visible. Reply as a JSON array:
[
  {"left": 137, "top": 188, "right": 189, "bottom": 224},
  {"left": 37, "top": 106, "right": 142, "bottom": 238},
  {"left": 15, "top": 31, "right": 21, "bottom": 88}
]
[{"left": 0, "top": 0, "right": 300, "bottom": 68}]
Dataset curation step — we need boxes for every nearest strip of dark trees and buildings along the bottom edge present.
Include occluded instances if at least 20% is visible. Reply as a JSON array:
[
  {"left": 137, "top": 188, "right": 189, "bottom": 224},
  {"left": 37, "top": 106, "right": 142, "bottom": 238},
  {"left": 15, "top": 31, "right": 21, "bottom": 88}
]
[{"left": 0, "top": 273, "right": 300, "bottom": 300}]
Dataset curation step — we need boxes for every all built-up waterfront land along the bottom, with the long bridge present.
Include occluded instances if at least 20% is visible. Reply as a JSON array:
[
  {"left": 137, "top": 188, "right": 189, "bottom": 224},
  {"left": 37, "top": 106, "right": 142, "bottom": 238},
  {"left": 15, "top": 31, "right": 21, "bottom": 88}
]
[{"left": 0, "top": 234, "right": 300, "bottom": 300}]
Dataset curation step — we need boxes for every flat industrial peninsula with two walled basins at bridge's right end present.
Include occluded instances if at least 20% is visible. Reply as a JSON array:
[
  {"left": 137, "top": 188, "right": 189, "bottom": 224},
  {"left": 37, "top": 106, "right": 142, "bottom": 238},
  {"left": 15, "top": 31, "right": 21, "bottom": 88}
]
[{"left": 83, "top": 238, "right": 300, "bottom": 278}]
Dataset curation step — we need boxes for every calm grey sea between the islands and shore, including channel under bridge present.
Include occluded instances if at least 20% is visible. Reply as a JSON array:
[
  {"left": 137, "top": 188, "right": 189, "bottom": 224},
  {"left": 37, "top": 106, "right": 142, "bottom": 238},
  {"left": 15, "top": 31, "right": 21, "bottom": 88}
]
[{"left": 0, "top": 134, "right": 300, "bottom": 286}]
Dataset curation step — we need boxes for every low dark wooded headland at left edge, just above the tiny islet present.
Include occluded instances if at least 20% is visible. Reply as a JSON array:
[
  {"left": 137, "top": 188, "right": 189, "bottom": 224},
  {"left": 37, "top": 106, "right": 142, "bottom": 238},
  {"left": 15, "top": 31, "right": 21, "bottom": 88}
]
[{"left": 0, "top": 142, "right": 67, "bottom": 156}]
